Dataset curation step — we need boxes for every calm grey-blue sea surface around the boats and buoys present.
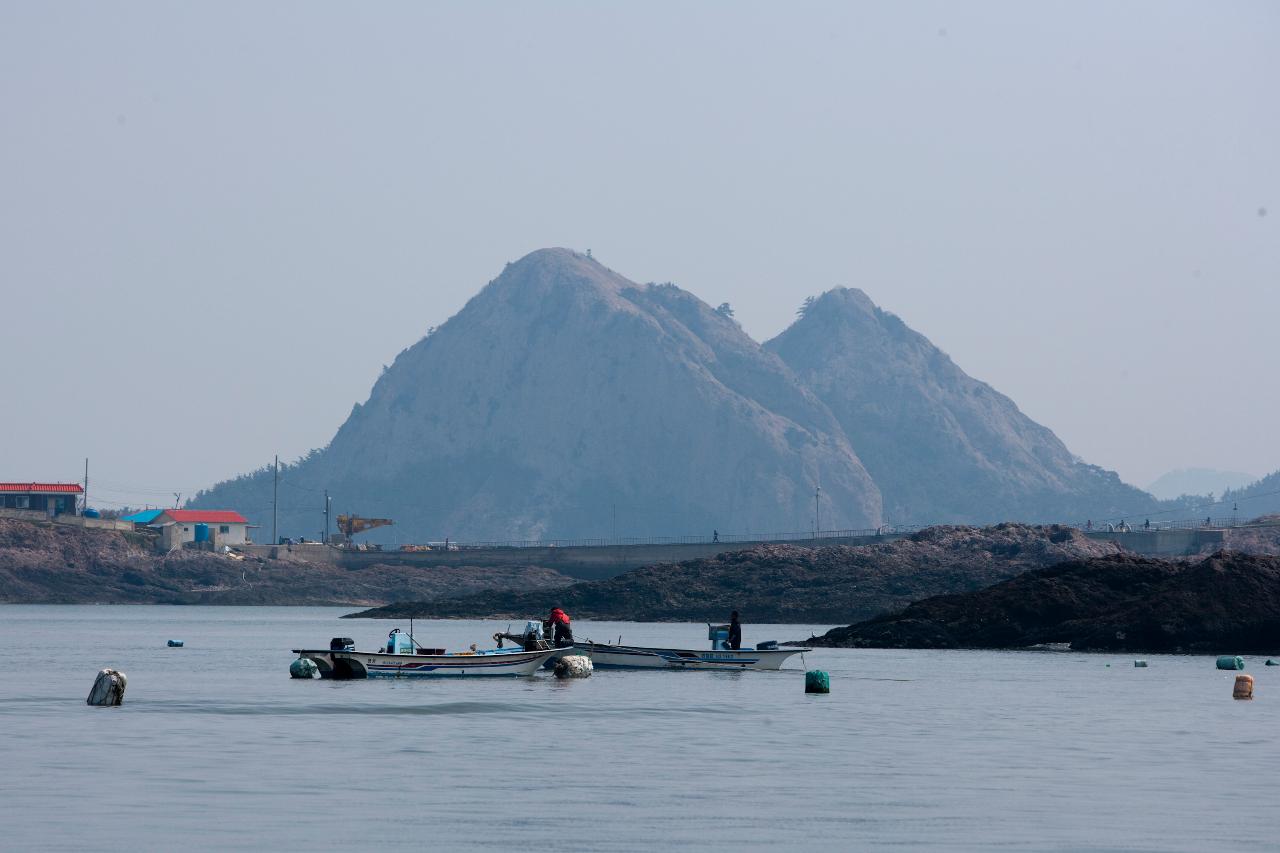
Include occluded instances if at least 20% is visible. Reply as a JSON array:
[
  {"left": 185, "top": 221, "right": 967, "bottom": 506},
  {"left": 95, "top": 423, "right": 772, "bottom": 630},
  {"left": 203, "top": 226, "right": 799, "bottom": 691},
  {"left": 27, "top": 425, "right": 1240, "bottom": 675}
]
[{"left": 0, "top": 606, "right": 1280, "bottom": 850}]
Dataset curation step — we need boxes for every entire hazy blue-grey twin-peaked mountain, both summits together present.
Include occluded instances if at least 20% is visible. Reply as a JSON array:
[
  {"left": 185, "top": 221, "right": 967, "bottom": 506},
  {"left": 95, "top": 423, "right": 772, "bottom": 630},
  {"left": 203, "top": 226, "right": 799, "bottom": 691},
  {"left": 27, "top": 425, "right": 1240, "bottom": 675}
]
[{"left": 193, "top": 248, "right": 1152, "bottom": 542}]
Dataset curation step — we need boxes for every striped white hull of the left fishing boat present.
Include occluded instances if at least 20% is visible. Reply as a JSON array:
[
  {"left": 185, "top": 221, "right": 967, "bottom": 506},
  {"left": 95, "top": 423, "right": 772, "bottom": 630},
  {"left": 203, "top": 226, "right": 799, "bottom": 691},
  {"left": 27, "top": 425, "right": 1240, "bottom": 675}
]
[{"left": 293, "top": 649, "right": 556, "bottom": 680}]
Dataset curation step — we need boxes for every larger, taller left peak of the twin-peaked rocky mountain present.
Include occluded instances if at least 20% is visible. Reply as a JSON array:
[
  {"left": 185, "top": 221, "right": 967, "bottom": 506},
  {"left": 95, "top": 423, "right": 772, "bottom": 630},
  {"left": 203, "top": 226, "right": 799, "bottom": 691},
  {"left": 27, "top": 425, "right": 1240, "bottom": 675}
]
[{"left": 195, "top": 248, "right": 881, "bottom": 542}]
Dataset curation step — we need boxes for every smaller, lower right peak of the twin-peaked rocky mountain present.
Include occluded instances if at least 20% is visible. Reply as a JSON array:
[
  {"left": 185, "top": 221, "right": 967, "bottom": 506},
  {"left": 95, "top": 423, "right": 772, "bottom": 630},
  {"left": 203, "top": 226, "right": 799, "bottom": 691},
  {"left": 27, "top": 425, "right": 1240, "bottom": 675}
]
[{"left": 765, "top": 288, "right": 1155, "bottom": 524}]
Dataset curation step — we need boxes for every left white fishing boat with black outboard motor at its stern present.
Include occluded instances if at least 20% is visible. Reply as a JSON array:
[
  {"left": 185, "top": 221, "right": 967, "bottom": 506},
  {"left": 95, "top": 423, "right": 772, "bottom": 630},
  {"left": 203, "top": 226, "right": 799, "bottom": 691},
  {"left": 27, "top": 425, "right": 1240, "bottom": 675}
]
[{"left": 293, "top": 629, "right": 563, "bottom": 680}]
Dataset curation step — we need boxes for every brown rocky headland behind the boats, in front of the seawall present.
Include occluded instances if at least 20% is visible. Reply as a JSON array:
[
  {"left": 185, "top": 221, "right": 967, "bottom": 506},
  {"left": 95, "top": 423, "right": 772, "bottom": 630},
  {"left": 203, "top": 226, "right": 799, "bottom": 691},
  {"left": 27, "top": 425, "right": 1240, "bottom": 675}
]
[{"left": 356, "top": 524, "right": 1119, "bottom": 622}]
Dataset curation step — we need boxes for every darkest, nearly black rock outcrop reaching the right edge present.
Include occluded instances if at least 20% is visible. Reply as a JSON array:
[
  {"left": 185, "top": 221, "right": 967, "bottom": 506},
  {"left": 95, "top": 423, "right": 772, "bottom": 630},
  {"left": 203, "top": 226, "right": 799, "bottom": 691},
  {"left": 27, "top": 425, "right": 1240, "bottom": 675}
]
[{"left": 806, "top": 552, "right": 1280, "bottom": 653}]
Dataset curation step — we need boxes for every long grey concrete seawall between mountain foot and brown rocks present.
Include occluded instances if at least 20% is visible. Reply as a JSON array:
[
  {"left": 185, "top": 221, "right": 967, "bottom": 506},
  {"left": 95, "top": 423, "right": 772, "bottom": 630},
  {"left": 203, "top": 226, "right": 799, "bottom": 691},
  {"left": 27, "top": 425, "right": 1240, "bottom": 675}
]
[{"left": 240, "top": 528, "right": 1229, "bottom": 580}]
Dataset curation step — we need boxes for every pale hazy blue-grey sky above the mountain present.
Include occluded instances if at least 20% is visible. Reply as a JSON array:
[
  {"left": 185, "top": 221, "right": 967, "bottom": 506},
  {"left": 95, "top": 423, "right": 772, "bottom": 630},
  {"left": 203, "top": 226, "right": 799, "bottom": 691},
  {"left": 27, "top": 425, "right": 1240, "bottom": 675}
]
[{"left": 0, "top": 0, "right": 1280, "bottom": 506}]
